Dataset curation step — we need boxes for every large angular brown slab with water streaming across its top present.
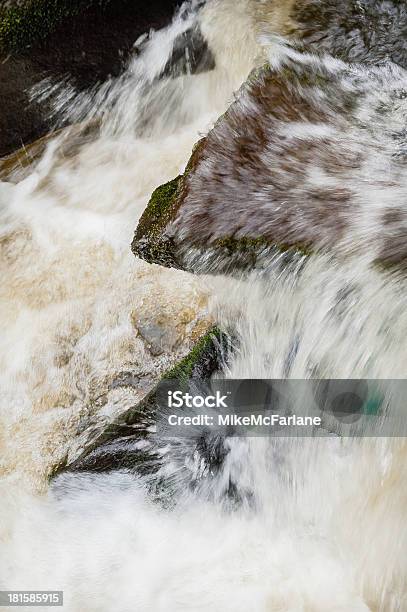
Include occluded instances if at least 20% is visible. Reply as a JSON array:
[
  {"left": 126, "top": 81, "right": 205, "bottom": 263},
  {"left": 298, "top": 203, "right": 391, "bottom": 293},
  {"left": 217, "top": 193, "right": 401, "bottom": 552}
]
[{"left": 132, "top": 45, "right": 407, "bottom": 272}]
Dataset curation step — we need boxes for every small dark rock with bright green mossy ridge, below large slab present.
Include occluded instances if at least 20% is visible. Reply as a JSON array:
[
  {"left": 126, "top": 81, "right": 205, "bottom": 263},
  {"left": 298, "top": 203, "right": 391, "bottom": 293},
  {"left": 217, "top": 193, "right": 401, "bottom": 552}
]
[{"left": 51, "top": 327, "right": 231, "bottom": 478}]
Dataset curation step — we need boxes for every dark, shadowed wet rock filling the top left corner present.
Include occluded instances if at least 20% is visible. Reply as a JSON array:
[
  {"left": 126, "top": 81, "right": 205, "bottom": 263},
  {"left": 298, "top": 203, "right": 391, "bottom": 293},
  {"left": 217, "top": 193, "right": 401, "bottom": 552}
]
[{"left": 0, "top": 0, "right": 180, "bottom": 156}]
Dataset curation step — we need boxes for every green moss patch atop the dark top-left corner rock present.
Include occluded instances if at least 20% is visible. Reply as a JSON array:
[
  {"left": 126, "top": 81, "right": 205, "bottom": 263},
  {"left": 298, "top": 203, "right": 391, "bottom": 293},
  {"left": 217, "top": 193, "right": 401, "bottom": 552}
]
[{"left": 0, "top": 0, "right": 111, "bottom": 54}]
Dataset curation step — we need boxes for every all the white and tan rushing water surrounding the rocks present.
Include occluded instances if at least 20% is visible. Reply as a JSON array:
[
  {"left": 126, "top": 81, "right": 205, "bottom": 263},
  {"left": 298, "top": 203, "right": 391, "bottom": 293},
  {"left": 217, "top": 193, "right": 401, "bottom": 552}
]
[{"left": 0, "top": 0, "right": 407, "bottom": 612}]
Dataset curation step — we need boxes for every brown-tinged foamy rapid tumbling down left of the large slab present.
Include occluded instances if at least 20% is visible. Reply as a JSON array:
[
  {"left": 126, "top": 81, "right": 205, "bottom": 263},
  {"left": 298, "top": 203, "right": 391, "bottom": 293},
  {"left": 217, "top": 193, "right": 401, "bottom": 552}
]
[{"left": 0, "top": 0, "right": 260, "bottom": 484}]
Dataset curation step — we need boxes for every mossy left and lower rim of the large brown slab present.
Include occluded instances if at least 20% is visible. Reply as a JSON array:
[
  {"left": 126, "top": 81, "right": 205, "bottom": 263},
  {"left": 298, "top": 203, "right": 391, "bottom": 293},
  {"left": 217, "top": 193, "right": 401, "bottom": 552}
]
[{"left": 132, "top": 58, "right": 334, "bottom": 273}]
